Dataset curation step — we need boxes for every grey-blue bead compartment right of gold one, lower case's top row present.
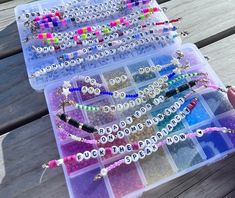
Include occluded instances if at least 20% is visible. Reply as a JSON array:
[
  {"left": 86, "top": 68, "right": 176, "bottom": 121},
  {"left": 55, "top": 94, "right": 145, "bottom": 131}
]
[{"left": 128, "top": 61, "right": 156, "bottom": 83}]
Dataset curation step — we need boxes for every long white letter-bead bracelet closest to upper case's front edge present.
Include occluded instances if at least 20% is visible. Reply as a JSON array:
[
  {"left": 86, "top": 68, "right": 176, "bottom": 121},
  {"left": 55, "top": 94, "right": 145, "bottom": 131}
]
[{"left": 30, "top": 34, "right": 178, "bottom": 78}]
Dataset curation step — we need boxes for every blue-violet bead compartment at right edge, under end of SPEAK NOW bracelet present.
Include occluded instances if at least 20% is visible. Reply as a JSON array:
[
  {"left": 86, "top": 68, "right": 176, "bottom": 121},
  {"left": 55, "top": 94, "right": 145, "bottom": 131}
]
[{"left": 219, "top": 114, "right": 235, "bottom": 148}]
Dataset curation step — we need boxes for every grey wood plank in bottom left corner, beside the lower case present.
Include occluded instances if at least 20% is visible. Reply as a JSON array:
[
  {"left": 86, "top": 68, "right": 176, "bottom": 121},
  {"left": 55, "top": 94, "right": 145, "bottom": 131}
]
[{"left": 0, "top": 116, "right": 68, "bottom": 198}]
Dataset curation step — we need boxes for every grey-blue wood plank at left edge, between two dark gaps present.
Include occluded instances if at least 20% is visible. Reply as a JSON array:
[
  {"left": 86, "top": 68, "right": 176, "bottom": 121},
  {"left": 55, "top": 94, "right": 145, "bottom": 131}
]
[{"left": 0, "top": 53, "right": 47, "bottom": 134}]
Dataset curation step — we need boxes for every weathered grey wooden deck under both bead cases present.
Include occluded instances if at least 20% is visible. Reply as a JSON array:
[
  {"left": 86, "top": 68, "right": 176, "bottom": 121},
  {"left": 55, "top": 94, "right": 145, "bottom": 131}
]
[{"left": 0, "top": 0, "right": 235, "bottom": 198}]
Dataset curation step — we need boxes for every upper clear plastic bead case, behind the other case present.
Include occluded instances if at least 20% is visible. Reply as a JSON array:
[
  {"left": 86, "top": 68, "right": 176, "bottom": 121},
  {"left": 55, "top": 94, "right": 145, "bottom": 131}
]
[{"left": 15, "top": 0, "right": 181, "bottom": 91}]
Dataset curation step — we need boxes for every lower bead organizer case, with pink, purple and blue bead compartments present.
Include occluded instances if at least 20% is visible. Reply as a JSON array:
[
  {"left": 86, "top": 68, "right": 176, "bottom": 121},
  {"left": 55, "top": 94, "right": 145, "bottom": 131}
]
[{"left": 45, "top": 44, "right": 235, "bottom": 198}]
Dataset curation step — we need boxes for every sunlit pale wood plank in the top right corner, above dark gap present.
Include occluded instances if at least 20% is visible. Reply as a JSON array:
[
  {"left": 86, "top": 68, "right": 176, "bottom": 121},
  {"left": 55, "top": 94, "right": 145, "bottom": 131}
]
[{"left": 162, "top": 0, "right": 235, "bottom": 43}]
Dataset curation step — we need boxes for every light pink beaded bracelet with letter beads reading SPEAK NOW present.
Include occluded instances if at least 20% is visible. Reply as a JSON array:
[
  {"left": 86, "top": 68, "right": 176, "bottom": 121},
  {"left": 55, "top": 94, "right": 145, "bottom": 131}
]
[{"left": 93, "top": 127, "right": 235, "bottom": 181}]
